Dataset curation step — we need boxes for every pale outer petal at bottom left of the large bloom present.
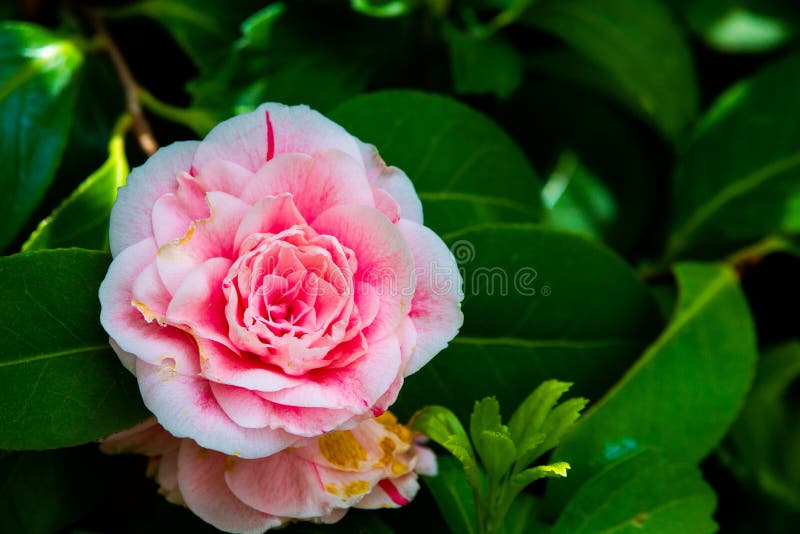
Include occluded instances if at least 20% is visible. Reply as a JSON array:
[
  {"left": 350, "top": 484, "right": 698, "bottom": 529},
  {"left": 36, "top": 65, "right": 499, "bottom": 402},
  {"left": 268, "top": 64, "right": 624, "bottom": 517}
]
[{"left": 136, "top": 360, "right": 298, "bottom": 458}]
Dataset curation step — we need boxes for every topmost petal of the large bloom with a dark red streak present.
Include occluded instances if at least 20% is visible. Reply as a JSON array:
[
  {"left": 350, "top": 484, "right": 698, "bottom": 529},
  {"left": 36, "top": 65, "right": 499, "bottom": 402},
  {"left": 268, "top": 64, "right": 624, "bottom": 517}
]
[{"left": 194, "top": 103, "right": 360, "bottom": 172}]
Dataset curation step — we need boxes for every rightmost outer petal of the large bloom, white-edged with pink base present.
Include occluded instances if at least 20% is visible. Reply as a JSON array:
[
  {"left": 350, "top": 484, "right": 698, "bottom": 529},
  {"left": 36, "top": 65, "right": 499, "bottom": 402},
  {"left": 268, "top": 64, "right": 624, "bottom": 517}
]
[{"left": 397, "top": 220, "right": 464, "bottom": 376}]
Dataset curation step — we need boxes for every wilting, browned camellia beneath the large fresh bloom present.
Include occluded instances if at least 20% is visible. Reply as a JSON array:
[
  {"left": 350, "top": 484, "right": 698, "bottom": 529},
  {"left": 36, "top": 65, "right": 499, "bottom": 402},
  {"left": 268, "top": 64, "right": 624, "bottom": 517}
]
[{"left": 100, "top": 412, "right": 436, "bottom": 532}]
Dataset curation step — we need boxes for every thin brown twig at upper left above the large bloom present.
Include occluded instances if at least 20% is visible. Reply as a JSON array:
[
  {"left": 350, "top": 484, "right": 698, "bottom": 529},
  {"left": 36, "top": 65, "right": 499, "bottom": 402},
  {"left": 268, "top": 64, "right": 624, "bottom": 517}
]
[{"left": 87, "top": 11, "right": 158, "bottom": 156}]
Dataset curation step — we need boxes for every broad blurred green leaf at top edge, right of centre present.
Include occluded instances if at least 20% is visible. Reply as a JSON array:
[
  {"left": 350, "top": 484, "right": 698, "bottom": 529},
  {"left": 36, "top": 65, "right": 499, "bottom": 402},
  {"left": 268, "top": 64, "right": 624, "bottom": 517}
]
[{"left": 520, "top": 0, "right": 698, "bottom": 140}]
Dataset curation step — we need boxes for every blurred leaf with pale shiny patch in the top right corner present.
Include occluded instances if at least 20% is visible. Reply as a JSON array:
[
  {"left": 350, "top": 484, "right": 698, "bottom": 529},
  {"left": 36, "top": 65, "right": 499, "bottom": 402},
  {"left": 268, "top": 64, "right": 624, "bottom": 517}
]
[{"left": 672, "top": 0, "right": 800, "bottom": 53}]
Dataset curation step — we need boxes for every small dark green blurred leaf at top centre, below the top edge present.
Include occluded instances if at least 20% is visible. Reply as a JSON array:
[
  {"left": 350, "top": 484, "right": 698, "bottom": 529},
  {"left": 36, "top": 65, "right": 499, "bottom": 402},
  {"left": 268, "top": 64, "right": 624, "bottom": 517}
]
[{"left": 444, "top": 24, "right": 522, "bottom": 98}]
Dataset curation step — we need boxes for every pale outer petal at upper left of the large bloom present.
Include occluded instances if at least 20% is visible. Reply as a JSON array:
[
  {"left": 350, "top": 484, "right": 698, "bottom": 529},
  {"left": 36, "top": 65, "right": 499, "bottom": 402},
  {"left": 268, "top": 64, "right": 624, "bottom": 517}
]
[{"left": 109, "top": 141, "right": 200, "bottom": 257}]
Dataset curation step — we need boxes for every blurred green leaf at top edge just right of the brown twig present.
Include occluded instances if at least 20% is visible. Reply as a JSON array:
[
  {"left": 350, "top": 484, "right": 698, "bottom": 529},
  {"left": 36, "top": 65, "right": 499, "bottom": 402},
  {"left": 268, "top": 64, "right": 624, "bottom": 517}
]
[{"left": 107, "top": 0, "right": 258, "bottom": 71}]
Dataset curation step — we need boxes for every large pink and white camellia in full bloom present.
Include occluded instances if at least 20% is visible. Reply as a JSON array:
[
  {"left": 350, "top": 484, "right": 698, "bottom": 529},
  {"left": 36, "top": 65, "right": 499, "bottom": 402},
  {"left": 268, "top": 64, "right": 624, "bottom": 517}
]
[{"left": 100, "top": 104, "right": 462, "bottom": 458}]
